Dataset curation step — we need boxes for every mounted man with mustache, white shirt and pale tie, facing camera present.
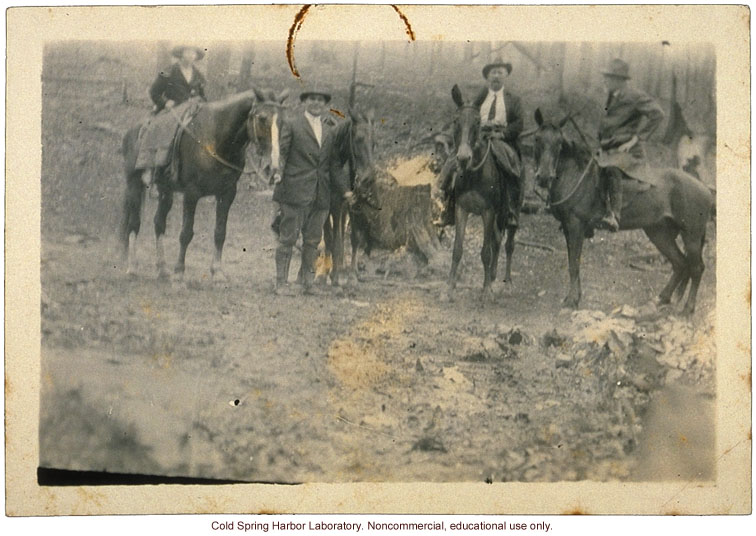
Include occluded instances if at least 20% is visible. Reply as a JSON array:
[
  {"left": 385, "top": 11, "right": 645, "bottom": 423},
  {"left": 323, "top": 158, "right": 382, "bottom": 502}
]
[{"left": 440, "top": 58, "right": 524, "bottom": 227}]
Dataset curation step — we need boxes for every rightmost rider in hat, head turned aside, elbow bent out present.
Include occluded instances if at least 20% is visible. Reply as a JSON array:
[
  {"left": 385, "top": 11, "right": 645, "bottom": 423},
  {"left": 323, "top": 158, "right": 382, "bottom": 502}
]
[{"left": 599, "top": 59, "right": 664, "bottom": 232}]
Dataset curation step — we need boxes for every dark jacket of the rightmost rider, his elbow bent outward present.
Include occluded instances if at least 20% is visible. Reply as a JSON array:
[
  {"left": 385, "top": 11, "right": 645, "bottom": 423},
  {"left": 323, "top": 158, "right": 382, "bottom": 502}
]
[{"left": 599, "top": 87, "right": 664, "bottom": 149}]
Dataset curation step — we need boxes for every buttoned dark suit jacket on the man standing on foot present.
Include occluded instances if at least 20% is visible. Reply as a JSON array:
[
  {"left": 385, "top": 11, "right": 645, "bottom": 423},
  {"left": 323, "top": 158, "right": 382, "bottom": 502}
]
[{"left": 273, "top": 111, "right": 346, "bottom": 209}]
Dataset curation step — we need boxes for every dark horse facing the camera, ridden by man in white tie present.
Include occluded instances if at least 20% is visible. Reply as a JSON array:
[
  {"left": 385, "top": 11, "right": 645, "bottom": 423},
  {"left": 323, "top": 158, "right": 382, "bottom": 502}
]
[{"left": 449, "top": 84, "right": 517, "bottom": 293}]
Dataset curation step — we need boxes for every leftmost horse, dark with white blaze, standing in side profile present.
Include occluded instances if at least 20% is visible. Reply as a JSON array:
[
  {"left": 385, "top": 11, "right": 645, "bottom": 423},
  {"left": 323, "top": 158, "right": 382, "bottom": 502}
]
[{"left": 119, "top": 89, "right": 288, "bottom": 279}]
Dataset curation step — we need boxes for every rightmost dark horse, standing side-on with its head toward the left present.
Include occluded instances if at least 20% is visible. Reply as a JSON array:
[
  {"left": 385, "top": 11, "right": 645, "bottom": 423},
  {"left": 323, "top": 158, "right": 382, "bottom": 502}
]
[{"left": 535, "top": 110, "right": 714, "bottom": 314}]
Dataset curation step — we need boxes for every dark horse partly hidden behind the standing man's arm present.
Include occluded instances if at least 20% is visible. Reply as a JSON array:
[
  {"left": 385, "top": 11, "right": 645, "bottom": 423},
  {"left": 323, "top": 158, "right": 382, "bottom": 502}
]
[{"left": 323, "top": 107, "right": 379, "bottom": 286}]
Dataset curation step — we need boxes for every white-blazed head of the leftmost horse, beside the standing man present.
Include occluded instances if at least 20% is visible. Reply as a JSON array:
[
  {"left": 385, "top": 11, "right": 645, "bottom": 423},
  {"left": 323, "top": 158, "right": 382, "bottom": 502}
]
[{"left": 246, "top": 88, "right": 289, "bottom": 176}]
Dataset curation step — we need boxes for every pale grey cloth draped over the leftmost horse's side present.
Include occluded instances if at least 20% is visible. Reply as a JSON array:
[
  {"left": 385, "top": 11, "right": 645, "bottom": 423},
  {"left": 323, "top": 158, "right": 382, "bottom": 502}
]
[{"left": 135, "top": 99, "right": 202, "bottom": 176}]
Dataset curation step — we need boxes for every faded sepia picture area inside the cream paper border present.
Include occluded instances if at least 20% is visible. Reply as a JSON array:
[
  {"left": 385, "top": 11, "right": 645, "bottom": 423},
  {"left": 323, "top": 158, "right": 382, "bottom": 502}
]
[{"left": 5, "top": 6, "right": 752, "bottom": 516}]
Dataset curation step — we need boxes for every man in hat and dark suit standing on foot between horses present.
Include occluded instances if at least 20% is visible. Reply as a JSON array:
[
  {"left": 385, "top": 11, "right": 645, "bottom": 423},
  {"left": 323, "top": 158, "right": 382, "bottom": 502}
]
[{"left": 273, "top": 90, "right": 349, "bottom": 295}]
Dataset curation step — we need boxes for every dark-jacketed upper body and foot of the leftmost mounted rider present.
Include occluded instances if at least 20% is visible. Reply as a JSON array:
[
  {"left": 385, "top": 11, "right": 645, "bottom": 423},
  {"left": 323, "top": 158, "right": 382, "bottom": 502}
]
[{"left": 142, "top": 45, "right": 206, "bottom": 187}]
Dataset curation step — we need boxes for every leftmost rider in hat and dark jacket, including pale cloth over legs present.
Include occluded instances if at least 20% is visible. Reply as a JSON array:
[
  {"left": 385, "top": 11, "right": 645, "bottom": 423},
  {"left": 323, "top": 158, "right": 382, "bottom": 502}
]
[{"left": 136, "top": 45, "right": 206, "bottom": 193}]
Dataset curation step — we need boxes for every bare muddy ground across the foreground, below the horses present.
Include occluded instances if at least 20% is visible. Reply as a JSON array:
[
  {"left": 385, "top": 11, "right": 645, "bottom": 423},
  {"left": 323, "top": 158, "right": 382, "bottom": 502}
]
[{"left": 40, "top": 190, "right": 715, "bottom": 483}]
